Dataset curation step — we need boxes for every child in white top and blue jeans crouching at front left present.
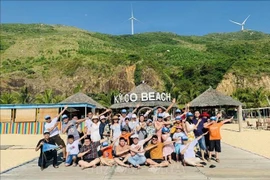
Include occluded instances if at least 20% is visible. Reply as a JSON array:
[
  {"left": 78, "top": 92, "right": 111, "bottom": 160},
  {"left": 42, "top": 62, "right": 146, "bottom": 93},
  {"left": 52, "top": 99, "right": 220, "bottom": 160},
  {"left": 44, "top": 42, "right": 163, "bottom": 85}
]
[{"left": 65, "top": 134, "right": 87, "bottom": 167}]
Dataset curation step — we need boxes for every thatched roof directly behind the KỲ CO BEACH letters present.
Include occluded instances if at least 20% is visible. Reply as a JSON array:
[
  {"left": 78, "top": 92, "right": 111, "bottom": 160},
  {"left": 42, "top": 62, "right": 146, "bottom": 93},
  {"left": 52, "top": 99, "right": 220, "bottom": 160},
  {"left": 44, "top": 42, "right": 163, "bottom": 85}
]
[{"left": 110, "top": 83, "right": 176, "bottom": 109}]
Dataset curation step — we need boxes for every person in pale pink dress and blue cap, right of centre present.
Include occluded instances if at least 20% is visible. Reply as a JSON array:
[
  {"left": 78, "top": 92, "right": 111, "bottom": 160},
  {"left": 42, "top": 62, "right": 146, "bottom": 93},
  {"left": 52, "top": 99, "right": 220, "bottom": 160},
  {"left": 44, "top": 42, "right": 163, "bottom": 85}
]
[{"left": 161, "top": 127, "right": 174, "bottom": 164}]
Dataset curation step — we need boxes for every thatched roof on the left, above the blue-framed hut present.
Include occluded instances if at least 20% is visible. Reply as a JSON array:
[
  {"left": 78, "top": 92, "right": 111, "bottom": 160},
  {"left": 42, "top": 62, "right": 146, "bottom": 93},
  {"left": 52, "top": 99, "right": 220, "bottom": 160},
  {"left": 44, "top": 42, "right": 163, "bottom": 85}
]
[{"left": 60, "top": 92, "right": 106, "bottom": 109}]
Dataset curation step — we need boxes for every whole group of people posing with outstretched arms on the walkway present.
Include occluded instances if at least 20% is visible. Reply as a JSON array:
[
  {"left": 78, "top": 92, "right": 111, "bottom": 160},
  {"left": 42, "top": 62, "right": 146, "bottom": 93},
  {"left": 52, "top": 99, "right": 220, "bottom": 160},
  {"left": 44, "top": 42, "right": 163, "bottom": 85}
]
[{"left": 36, "top": 100, "right": 232, "bottom": 170}]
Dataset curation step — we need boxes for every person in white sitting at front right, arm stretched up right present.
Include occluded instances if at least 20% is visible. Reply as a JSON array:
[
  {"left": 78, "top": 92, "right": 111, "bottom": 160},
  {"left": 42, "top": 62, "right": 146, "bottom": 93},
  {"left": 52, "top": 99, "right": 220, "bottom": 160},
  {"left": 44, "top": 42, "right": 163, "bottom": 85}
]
[{"left": 180, "top": 132, "right": 208, "bottom": 167}]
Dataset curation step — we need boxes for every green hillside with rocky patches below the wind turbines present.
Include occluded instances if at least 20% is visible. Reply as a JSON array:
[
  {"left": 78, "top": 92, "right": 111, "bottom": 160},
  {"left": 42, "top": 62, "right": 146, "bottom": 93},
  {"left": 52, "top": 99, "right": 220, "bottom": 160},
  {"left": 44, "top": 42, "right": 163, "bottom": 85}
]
[{"left": 0, "top": 24, "right": 270, "bottom": 105}]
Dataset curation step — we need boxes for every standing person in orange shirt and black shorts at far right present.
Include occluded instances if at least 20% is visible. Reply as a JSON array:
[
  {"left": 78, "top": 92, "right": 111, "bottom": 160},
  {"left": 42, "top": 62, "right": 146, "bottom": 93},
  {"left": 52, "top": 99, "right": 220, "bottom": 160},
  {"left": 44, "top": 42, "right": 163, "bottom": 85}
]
[{"left": 204, "top": 114, "right": 233, "bottom": 162}]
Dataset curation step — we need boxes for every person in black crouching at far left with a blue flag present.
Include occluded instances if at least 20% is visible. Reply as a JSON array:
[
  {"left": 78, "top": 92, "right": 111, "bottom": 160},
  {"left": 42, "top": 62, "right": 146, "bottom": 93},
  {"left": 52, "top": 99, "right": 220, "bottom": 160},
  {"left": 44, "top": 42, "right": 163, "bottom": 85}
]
[{"left": 35, "top": 131, "right": 58, "bottom": 171}]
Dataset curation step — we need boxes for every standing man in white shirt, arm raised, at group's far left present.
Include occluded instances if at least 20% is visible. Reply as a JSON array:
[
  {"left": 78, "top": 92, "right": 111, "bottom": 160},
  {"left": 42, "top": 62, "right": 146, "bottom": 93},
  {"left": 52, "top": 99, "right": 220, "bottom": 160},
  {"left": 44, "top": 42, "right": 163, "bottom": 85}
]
[{"left": 45, "top": 106, "right": 68, "bottom": 161}]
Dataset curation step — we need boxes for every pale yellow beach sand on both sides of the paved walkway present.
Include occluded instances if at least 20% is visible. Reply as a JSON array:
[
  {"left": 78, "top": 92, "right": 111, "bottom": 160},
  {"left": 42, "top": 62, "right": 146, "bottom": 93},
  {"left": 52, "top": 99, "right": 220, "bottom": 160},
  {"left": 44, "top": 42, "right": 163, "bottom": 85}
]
[{"left": 0, "top": 122, "right": 270, "bottom": 172}]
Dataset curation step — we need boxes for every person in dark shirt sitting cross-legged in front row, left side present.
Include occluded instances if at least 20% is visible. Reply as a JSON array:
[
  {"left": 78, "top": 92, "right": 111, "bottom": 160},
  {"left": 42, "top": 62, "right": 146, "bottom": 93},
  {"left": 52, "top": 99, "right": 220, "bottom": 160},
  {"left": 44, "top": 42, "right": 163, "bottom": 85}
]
[{"left": 78, "top": 136, "right": 106, "bottom": 169}]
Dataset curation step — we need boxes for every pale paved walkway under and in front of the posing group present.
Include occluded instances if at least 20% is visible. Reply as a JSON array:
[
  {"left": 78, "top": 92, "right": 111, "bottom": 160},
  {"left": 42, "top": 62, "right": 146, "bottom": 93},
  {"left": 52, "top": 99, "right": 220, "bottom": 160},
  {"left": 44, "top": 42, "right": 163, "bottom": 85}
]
[{"left": 0, "top": 144, "right": 270, "bottom": 180}]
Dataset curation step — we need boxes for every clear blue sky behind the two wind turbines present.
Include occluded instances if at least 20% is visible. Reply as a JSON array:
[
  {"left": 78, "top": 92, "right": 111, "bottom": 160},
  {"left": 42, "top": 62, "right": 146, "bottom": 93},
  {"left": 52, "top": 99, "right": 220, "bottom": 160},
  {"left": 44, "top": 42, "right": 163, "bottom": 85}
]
[{"left": 1, "top": 0, "right": 270, "bottom": 35}]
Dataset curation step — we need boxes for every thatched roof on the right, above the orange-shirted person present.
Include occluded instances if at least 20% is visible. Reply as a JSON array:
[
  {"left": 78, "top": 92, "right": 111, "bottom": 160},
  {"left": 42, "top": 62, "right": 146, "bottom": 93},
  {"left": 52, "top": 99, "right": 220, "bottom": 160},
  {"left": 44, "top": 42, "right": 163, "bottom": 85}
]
[{"left": 190, "top": 87, "right": 243, "bottom": 107}]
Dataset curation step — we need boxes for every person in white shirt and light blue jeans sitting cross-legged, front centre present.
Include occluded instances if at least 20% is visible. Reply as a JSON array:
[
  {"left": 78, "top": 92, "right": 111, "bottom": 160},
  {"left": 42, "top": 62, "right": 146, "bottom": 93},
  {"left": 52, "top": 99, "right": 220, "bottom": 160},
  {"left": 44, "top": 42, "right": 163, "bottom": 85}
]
[{"left": 128, "top": 134, "right": 152, "bottom": 169}]
